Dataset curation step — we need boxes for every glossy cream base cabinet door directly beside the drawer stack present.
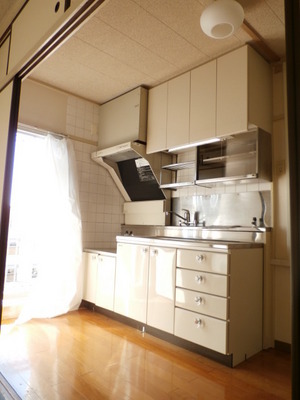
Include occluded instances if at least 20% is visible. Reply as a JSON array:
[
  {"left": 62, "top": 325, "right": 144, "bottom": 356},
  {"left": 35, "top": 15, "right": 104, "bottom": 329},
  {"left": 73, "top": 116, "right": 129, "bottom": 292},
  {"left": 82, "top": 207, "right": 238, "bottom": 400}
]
[{"left": 147, "top": 247, "right": 176, "bottom": 333}]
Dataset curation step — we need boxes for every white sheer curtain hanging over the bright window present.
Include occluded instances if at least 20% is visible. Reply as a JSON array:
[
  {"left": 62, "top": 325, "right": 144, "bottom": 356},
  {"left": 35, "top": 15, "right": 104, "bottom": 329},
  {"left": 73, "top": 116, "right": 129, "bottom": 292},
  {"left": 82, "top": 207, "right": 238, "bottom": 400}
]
[{"left": 17, "top": 135, "right": 83, "bottom": 323}]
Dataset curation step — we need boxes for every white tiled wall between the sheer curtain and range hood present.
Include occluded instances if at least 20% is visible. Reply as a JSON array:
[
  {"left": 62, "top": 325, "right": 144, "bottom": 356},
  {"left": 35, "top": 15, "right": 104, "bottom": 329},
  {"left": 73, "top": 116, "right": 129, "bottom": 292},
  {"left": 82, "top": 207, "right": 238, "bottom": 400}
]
[{"left": 66, "top": 96, "right": 124, "bottom": 250}]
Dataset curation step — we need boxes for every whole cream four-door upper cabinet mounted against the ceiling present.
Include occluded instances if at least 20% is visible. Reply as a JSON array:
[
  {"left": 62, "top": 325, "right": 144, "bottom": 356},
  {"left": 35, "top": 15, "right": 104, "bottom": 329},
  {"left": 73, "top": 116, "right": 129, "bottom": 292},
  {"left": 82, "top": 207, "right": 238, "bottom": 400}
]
[{"left": 147, "top": 45, "right": 272, "bottom": 153}]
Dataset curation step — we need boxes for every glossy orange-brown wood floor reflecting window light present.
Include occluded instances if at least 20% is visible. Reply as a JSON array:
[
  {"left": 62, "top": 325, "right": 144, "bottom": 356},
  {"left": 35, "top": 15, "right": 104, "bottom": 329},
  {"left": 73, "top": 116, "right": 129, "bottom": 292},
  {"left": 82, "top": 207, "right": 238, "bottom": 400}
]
[{"left": 0, "top": 310, "right": 291, "bottom": 400}]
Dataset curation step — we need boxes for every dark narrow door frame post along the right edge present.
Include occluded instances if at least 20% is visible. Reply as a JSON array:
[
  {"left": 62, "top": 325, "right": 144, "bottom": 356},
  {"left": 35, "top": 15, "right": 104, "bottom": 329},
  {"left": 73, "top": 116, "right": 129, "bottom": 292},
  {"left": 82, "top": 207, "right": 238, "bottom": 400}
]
[{"left": 285, "top": 0, "right": 300, "bottom": 399}]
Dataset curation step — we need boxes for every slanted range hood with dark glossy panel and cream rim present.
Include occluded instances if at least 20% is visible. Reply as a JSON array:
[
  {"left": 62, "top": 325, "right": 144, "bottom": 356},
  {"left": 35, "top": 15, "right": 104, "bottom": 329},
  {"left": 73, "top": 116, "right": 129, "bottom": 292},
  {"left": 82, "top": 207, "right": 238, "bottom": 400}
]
[{"left": 91, "top": 141, "right": 170, "bottom": 201}]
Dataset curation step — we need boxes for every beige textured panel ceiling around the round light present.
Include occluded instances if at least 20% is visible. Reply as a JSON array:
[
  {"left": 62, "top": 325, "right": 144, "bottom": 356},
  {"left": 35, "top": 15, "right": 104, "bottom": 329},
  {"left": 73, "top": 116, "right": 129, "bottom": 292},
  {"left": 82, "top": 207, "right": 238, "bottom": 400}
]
[{"left": 0, "top": 0, "right": 285, "bottom": 104}]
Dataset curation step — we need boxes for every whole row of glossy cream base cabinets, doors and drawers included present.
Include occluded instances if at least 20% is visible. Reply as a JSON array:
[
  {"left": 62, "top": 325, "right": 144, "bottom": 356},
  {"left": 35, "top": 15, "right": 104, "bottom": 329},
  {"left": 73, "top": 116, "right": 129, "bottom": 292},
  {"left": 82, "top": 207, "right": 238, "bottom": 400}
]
[{"left": 92, "top": 236, "right": 263, "bottom": 367}]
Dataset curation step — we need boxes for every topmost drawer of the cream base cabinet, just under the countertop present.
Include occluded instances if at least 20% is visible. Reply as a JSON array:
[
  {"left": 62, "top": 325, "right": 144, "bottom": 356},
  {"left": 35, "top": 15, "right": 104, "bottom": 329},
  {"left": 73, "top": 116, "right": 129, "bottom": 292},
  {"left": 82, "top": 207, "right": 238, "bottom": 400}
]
[{"left": 177, "top": 249, "right": 229, "bottom": 275}]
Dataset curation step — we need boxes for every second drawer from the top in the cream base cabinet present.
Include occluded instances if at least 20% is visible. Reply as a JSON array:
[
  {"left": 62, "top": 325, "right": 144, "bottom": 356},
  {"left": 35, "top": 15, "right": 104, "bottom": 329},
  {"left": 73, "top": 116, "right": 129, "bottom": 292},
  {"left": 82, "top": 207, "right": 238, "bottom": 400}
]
[{"left": 176, "top": 268, "right": 229, "bottom": 297}]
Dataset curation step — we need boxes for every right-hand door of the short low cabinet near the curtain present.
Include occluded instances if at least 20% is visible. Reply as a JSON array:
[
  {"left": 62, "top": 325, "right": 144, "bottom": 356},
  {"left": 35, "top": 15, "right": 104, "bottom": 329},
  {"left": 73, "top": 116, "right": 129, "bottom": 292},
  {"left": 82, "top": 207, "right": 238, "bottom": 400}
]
[{"left": 96, "top": 255, "right": 116, "bottom": 311}]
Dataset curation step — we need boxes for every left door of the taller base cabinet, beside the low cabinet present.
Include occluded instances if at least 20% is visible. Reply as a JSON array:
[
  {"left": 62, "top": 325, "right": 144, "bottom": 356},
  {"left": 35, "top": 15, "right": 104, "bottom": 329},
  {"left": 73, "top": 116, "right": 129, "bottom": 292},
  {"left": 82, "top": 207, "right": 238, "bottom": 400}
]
[{"left": 114, "top": 243, "right": 149, "bottom": 323}]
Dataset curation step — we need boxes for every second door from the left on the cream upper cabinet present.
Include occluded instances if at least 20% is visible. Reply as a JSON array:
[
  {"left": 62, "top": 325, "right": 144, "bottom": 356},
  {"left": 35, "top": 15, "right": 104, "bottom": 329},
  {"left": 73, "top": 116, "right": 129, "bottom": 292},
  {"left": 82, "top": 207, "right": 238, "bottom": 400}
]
[{"left": 167, "top": 72, "right": 191, "bottom": 149}]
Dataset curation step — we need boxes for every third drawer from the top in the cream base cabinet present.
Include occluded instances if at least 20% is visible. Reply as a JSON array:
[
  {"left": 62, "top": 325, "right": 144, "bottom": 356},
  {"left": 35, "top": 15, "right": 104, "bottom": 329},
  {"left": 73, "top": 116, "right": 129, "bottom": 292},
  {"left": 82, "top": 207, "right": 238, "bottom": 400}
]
[{"left": 176, "top": 288, "right": 229, "bottom": 320}]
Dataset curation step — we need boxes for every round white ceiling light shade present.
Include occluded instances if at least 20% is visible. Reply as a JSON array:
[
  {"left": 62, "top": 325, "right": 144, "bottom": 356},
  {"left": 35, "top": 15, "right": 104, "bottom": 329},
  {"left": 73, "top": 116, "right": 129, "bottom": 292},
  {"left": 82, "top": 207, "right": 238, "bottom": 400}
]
[{"left": 200, "top": 0, "right": 244, "bottom": 39}]
